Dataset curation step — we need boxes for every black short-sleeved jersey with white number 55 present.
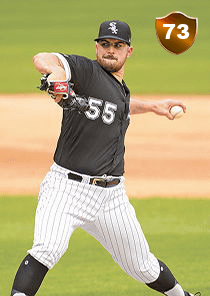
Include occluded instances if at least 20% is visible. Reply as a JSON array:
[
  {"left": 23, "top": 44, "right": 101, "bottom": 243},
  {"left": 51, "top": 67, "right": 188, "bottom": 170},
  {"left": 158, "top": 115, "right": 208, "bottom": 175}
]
[{"left": 54, "top": 55, "right": 130, "bottom": 176}]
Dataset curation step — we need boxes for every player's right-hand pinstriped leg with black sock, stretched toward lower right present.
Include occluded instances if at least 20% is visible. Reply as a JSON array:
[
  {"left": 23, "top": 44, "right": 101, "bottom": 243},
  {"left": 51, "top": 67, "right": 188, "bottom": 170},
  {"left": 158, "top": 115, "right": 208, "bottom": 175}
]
[{"left": 83, "top": 186, "right": 194, "bottom": 296}]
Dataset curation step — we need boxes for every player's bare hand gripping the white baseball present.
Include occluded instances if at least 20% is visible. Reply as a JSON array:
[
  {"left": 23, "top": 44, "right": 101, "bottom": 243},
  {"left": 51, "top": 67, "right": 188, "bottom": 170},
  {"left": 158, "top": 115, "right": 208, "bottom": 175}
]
[{"left": 153, "top": 99, "right": 186, "bottom": 120}]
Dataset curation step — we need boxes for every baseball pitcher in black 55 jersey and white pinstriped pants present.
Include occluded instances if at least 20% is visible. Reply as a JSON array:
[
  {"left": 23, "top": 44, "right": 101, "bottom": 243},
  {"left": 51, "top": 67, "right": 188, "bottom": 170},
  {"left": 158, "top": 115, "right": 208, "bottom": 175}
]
[{"left": 11, "top": 20, "right": 200, "bottom": 296}]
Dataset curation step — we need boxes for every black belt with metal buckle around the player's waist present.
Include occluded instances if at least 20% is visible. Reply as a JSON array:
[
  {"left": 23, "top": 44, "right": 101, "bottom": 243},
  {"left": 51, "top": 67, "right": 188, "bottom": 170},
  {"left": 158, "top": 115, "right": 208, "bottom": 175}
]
[{"left": 68, "top": 173, "right": 120, "bottom": 187}]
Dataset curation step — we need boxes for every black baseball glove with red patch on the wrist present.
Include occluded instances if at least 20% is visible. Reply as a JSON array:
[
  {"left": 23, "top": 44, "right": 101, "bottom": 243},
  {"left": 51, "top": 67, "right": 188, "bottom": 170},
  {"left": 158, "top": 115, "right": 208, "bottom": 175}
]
[{"left": 38, "top": 74, "right": 90, "bottom": 113}]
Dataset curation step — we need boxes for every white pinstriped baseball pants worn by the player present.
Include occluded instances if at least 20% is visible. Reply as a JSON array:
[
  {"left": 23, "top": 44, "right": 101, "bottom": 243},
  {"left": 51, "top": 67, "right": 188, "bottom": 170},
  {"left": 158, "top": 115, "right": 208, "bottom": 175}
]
[{"left": 28, "top": 164, "right": 160, "bottom": 283}]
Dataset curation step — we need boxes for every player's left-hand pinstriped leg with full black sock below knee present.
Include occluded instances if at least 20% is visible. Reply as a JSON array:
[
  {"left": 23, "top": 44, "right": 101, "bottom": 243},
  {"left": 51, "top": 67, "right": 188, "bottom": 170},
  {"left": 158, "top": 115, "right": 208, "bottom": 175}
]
[{"left": 11, "top": 169, "right": 75, "bottom": 296}]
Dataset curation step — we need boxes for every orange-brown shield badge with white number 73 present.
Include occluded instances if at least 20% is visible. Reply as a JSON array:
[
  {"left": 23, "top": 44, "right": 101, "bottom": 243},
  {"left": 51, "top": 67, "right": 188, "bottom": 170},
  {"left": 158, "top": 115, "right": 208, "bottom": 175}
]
[{"left": 155, "top": 12, "right": 198, "bottom": 55}]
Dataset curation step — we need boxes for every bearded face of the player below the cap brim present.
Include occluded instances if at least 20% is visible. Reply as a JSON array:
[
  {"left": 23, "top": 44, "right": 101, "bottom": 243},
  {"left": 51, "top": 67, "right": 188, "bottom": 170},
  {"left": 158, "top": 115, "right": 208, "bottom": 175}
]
[{"left": 96, "top": 39, "right": 133, "bottom": 72}]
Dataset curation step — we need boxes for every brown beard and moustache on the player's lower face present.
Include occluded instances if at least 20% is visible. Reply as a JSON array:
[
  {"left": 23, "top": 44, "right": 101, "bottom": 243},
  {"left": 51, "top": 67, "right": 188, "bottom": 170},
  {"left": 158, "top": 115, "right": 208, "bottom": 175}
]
[{"left": 96, "top": 54, "right": 125, "bottom": 72}]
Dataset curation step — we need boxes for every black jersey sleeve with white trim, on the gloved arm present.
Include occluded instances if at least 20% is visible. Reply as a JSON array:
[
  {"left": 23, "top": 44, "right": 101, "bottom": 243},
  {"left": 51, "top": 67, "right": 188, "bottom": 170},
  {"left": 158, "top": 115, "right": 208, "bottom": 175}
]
[{"left": 53, "top": 53, "right": 93, "bottom": 94}]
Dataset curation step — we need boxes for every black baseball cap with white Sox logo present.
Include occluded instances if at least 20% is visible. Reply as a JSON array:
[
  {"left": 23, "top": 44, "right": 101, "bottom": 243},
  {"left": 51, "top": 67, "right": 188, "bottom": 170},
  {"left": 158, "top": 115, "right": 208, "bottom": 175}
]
[{"left": 94, "top": 20, "right": 131, "bottom": 46}]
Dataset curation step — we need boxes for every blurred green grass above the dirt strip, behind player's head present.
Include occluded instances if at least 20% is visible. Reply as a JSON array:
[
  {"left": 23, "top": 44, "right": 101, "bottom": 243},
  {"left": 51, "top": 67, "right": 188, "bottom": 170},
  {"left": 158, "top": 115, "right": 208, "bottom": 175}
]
[{"left": 0, "top": 0, "right": 210, "bottom": 94}]
